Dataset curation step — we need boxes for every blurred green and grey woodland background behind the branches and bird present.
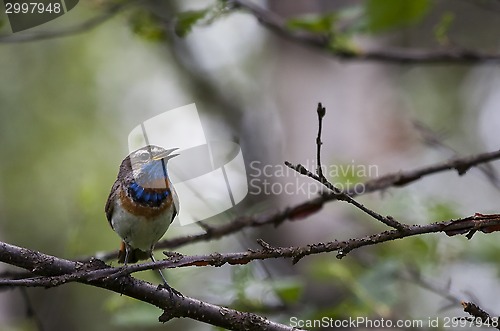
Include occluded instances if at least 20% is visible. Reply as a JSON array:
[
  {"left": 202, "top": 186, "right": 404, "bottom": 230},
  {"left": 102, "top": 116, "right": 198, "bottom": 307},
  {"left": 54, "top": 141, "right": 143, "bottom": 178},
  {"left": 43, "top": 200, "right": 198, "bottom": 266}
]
[{"left": 0, "top": 0, "right": 500, "bottom": 330}]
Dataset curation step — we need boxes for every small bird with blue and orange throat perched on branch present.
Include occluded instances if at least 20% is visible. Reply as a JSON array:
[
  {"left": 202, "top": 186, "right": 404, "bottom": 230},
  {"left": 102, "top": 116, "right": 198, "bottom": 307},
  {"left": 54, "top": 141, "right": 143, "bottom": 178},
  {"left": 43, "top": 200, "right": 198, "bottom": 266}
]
[{"left": 105, "top": 145, "right": 179, "bottom": 292}]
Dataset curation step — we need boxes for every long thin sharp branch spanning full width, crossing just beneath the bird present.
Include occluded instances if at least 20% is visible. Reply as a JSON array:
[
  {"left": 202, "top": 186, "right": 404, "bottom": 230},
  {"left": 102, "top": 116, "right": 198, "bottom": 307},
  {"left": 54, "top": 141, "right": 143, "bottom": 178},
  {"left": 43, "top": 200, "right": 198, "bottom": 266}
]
[{"left": 0, "top": 214, "right": 500, "bottom": 294}]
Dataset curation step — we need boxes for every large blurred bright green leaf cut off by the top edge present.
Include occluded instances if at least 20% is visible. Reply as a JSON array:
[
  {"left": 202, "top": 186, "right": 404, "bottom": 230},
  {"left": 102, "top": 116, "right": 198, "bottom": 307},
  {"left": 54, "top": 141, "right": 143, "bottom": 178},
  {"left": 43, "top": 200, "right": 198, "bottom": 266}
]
[{"left": 365, "top": 0, "right": 431, "bottom": 32}]
